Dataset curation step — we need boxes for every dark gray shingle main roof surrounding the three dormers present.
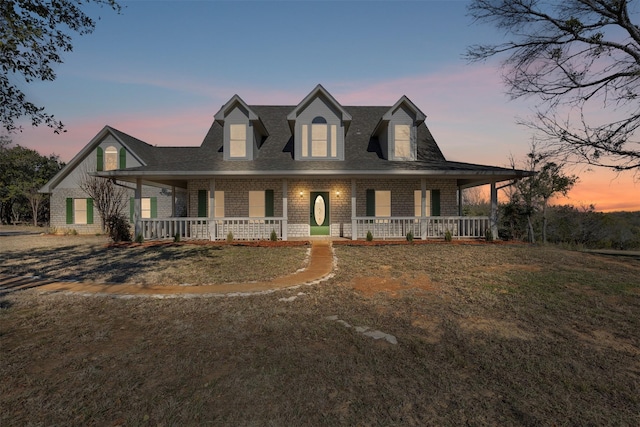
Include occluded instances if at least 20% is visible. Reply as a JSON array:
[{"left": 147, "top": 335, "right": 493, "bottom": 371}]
[{"left": 105, "top": 105, "right": 522, "bottom": 184}]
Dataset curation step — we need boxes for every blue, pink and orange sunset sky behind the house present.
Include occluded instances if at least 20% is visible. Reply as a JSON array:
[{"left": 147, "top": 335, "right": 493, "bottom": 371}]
[{"left": 12, "top": 0, "right": 640, "bottom": 211}]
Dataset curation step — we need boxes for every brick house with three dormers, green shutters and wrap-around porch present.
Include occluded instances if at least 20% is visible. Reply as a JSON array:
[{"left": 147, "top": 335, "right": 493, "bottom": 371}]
[{"left": 41, "top": 85, "right": 530, "bottom": 240}]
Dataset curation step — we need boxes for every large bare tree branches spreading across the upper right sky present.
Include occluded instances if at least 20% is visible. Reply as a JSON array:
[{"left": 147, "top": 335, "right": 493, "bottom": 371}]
[{"left": 466, "top": 0, "right": 640, "bottom": 171}]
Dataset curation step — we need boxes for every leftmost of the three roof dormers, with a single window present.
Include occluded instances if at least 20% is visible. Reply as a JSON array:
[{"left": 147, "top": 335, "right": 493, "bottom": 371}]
[{"left": 214, "top": 95, "right": 269, "bottom": 160}]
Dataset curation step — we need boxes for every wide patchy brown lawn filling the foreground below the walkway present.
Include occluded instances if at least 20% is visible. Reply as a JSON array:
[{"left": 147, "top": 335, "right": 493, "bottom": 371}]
[{"left": 0, "top": 237, "right": 640, "bottom": 426}]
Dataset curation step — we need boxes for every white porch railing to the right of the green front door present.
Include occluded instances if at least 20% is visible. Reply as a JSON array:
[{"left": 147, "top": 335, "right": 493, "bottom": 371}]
[{"left": 355, "top": 216, "right": 491, "bottom": 239}]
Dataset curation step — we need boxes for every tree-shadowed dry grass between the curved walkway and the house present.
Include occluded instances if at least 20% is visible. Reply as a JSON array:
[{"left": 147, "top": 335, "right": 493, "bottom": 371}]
[{"left": 0, "top": 235, "right": 308, "bottom": 286}]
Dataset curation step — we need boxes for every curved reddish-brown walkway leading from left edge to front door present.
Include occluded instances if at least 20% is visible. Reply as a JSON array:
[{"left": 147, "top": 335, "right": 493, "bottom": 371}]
[{"left": 0, "top": 240, "right": 334, "bottom": 298}]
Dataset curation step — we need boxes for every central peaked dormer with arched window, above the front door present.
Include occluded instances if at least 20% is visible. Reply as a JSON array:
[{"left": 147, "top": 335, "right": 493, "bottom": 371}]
[{"left": 287, "top": 85, "right": 351, "bottom": 160}]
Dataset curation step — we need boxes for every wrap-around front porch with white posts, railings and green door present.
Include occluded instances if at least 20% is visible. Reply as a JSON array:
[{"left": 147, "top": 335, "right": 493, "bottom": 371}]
[{"left": 134, "top": 178, "right": 497, "bottom": 240}]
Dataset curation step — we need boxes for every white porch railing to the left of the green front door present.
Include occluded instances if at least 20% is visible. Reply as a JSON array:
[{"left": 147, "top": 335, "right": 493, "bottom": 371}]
[{"left": 140, "top": 217, "right": 286, "bottom": 240}]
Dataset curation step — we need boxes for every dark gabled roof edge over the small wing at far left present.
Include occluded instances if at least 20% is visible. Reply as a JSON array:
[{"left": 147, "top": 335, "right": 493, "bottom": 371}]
[{"left": 38, "top": 125, "right": 156, "bottom": 193}]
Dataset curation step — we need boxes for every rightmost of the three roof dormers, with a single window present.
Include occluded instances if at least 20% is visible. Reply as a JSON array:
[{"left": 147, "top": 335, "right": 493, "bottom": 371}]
[{"left": 373, "top": 96, "right": 427, "bottom": 161}]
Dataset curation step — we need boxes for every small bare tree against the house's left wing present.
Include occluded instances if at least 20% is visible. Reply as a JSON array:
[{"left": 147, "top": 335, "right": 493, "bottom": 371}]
[{"left": 78, "top": 170, "right": 128, "bottom": 232}]
